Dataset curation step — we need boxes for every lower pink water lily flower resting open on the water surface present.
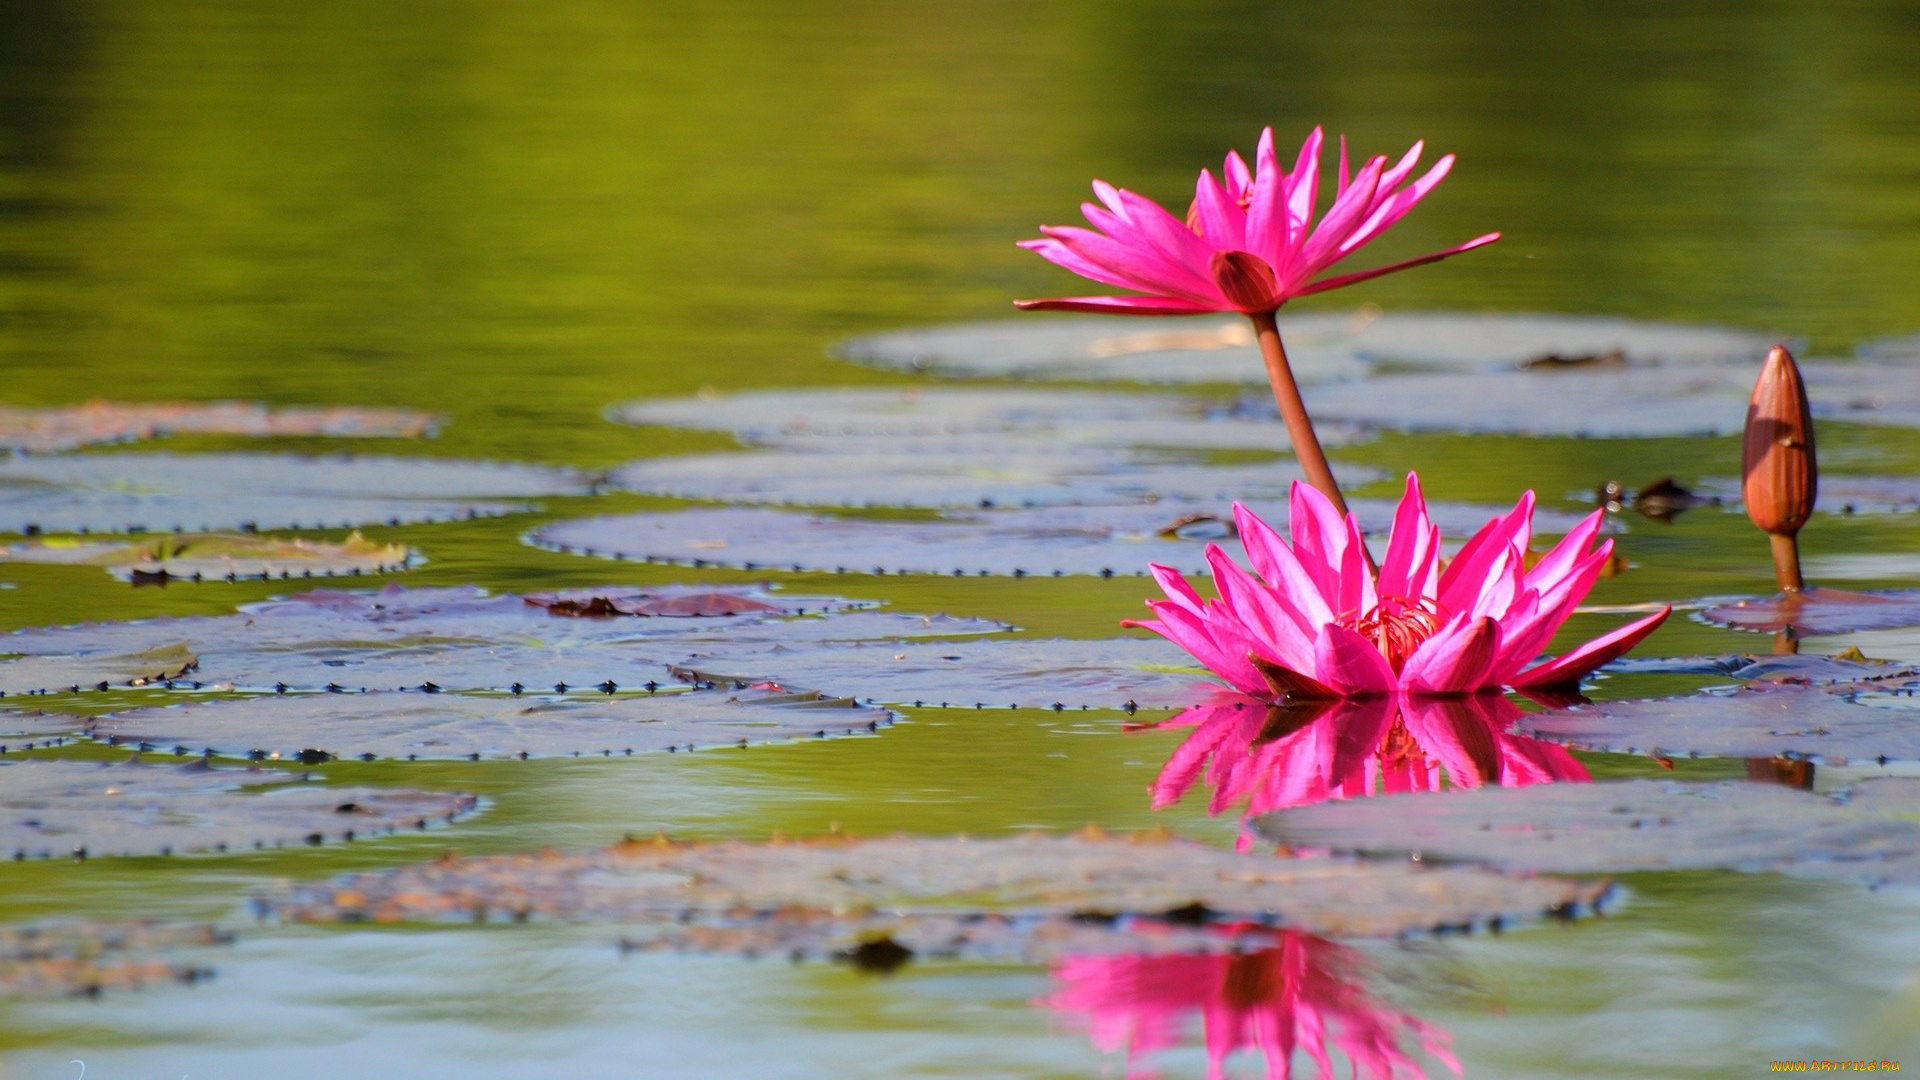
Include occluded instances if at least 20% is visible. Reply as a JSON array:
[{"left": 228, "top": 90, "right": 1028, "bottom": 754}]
[{"left": 1123, "top": 473, "right": 1672, "bottom": 698}]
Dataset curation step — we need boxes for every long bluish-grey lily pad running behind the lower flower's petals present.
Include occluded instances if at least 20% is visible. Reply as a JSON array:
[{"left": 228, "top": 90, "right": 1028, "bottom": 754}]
[{"left": 528, "top": 500, "right": 1578, "bottom": 577}]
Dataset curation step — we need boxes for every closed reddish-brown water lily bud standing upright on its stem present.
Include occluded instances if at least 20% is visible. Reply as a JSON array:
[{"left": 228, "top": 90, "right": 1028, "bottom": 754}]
[{"left": 1740, "top": 346, "right": 1818, "bottom": 590}]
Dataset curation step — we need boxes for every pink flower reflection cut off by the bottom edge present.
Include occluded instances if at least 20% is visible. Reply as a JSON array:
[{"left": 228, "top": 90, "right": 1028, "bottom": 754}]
[{"left": 1041, "top": 930, "right": 1461, "bottom": 1080}]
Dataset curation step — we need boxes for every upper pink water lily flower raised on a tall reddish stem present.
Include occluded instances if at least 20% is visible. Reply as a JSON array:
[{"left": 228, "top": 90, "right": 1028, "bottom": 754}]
[{"left": 1016, "top": 127, "right": 1500, "bottom": 513}]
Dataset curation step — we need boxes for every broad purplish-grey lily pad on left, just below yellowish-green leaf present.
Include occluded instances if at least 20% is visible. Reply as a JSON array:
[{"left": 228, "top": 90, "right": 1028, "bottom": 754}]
[{"left": 0, "top": 586, "right": 1006, "bottom": 694}]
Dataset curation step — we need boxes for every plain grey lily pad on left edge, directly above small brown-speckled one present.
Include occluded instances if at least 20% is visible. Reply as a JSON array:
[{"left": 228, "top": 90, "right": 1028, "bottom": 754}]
[{"left": 0, "top": 757, "right": 478, "bottom": 859}]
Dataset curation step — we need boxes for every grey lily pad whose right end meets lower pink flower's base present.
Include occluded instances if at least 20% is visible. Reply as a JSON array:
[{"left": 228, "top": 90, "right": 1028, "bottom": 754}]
[{"left": 676, "top": 638, "right": 1219, "bottom": 709}]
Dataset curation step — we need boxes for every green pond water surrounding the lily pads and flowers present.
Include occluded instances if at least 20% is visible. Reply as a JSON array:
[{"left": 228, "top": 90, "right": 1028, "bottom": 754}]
[{"left": 0, "top": 0, "right": 1920, "bottom": 1080}]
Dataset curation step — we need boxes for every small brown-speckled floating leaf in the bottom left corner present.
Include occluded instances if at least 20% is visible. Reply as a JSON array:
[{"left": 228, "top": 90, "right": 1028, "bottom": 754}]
[{"left": 0, "top": 920, "right": 232, "bottom": 997}]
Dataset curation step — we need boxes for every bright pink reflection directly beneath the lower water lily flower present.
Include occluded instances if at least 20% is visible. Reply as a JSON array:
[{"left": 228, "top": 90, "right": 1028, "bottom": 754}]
[{"left": 1154, "top": 692, "right": 1592, "bottom": 817}]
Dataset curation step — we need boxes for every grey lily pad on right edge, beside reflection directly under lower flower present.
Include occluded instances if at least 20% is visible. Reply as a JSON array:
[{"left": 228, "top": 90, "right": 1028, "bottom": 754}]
[{"left": 1515, "top": 673, "right": 1920, "bottom": 765}]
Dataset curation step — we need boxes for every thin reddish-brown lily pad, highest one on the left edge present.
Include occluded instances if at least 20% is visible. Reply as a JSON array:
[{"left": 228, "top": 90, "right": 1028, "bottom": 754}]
[{"left": 0, "top": 402, "right": 438, "bottom": 454}]
